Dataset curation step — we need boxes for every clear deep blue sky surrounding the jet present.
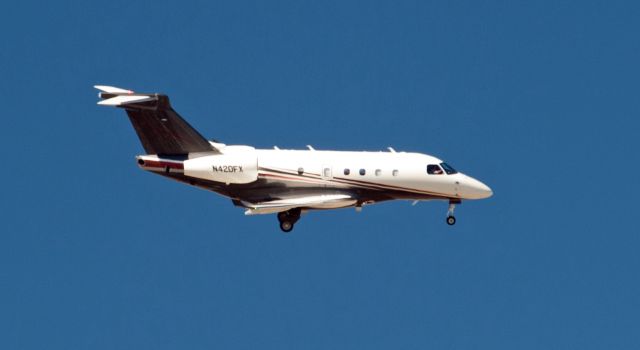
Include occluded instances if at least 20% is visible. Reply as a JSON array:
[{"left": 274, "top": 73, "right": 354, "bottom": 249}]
[{"left": 0, "top": 0, "right": 640, "bottom": 349}]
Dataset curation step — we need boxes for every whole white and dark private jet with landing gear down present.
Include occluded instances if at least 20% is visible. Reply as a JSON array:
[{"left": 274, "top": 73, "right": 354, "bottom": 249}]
[{"left": 94, "top": 85, "right": 493, "bottom": 232}]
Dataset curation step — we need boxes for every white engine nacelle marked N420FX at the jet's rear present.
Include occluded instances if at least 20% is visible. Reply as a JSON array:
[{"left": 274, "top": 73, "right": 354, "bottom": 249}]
[{"left": 184, "top": 146, "right": 258, "bottom": 184}]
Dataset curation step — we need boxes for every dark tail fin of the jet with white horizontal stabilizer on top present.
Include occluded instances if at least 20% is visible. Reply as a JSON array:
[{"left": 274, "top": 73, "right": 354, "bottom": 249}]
[{"left": 95, "top": 85, "right": 219, "bottom": 155}]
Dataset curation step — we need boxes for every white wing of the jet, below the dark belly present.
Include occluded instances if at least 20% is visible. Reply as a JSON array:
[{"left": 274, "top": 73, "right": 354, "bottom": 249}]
[{"left": 241, "top": 194, "right": 357, "bottom": 215}]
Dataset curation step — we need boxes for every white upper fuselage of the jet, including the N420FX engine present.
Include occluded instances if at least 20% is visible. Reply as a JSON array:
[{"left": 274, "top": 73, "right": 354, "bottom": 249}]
[{"left": 139, "top": 144, "right": 492, "bottom": 205}]
